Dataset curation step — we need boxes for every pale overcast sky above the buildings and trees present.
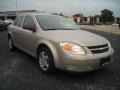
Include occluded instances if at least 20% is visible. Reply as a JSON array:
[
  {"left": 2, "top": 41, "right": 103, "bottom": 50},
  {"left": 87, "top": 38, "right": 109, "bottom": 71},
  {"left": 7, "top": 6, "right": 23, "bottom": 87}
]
[{"left": 0, "top": 0, "right": 120, "bottom": 17}]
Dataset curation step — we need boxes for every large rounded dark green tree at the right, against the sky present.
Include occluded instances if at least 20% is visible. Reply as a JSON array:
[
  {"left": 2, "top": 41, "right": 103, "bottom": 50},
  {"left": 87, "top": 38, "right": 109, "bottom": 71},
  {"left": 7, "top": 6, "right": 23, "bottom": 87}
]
[{"left": 100, "top": 9, "right": 114, "bottom": 23}]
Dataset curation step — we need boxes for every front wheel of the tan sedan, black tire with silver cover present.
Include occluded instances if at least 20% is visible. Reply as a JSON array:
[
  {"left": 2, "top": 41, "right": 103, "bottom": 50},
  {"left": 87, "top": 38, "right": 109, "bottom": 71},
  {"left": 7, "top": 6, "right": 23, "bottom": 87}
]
[{"left": 38, "top": 47, "right": 55, "bottom": 74}]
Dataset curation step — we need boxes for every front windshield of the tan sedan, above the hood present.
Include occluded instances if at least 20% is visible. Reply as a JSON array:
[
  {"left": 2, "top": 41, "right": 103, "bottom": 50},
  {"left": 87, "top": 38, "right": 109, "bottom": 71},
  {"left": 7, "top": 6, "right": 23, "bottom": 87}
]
[{"left": 36, "top": 15, "right": 80, "bottom": 30}]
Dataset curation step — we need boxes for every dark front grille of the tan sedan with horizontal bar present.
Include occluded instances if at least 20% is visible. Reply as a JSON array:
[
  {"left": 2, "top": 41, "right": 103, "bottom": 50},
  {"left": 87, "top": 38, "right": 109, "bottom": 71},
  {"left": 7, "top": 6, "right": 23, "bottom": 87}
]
[{"left": 88, "top": 44, "right": 109, "bottom": 54}]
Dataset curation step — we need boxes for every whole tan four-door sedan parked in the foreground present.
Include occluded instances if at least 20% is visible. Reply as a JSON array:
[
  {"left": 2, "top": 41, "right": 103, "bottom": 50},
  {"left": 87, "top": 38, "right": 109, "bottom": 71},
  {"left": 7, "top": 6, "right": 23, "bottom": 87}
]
[{"left": 8, "top": 13, "right": 113, "bottom": 73}]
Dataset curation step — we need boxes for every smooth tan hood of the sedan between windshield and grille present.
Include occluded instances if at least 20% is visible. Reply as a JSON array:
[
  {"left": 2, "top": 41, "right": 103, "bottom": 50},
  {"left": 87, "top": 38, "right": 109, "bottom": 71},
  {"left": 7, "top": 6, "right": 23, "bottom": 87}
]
[{"left": 45, "top": 30, "right": 108, "bottom": 46}]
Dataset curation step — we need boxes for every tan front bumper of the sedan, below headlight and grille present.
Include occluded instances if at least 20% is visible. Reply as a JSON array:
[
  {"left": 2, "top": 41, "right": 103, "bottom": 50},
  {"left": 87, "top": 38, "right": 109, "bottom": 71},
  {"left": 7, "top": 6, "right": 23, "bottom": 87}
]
[{"left": 56, "top": 49, "right": 114, "bottom": 72}]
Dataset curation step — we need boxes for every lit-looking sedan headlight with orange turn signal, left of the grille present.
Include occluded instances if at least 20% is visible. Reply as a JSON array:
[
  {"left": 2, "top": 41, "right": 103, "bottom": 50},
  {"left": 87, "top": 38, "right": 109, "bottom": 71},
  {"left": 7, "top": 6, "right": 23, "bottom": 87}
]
[{"left": 60, "top": 42, "right": 85, "bottom": 54}]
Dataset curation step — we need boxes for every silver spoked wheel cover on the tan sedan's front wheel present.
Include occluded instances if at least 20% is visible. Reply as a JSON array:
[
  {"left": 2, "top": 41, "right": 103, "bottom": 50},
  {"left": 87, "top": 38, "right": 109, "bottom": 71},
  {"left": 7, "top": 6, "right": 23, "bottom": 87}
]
[{"left": 39, "top": 51, "right": 49, "bottom": 71}]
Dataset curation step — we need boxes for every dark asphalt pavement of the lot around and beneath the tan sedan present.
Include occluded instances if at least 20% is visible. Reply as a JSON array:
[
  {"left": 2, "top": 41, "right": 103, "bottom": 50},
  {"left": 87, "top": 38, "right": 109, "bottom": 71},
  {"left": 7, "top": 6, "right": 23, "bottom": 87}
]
[{"left": 0, "top": 31, "right": 120, "bottom": 90}]
